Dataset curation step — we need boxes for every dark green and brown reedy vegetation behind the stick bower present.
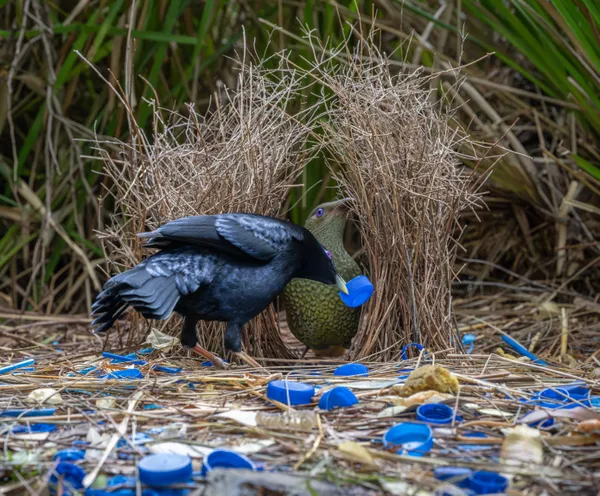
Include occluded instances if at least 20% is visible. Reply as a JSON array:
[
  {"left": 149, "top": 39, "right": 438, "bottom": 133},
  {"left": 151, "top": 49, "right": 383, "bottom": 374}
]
[{"left": 0, "top": 0, "right": 600, "bottom": 314}]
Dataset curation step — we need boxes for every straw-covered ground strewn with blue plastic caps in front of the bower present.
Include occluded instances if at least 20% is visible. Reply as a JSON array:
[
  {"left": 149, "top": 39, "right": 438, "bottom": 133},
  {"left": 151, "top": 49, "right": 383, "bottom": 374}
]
[{"left": 0, "top": 320, "right": 600, "bottom": 496}]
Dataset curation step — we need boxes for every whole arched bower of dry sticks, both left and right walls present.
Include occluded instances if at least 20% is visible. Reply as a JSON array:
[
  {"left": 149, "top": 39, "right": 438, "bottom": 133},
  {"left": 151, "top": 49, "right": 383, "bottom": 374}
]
[{"left": 99, "top": 33, "right": 490, "bottom": 361}]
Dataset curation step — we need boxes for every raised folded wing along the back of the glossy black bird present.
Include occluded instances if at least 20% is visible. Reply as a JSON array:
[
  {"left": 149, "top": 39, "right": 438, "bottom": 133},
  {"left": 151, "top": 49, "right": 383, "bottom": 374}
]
[{"left": 138, "top": 214, "right": 303, "bottom": 261}]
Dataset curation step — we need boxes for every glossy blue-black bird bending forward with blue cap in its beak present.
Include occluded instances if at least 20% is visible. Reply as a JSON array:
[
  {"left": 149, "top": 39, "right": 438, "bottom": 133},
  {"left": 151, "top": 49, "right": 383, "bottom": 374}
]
[{"left": 92, "top": 214, "right": 347, "bottom": 366}]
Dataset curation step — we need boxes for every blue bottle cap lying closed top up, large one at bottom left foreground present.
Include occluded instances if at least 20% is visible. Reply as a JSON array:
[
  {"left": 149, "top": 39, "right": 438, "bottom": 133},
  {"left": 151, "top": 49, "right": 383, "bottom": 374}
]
[{"left": 138, "top": 453, "right": 192, "bottom": 486}]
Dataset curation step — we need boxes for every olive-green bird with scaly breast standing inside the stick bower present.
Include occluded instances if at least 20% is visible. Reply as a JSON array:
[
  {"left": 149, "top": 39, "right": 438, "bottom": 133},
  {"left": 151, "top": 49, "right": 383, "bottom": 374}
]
[{"left": 282, "top": 202, "right": 360, "bottom": 355}]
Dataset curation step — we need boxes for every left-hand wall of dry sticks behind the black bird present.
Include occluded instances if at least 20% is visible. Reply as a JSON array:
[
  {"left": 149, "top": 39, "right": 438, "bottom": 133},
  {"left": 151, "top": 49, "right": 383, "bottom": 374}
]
[{"left": 94, "top": 45, "right": 320, "bottom": 356}]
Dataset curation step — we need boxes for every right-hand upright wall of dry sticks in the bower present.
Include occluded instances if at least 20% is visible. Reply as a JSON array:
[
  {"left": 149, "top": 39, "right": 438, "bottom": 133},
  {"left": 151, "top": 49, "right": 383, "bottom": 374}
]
[{"left": 302, "top": 28, "right": 485, "bottom": 360}]
